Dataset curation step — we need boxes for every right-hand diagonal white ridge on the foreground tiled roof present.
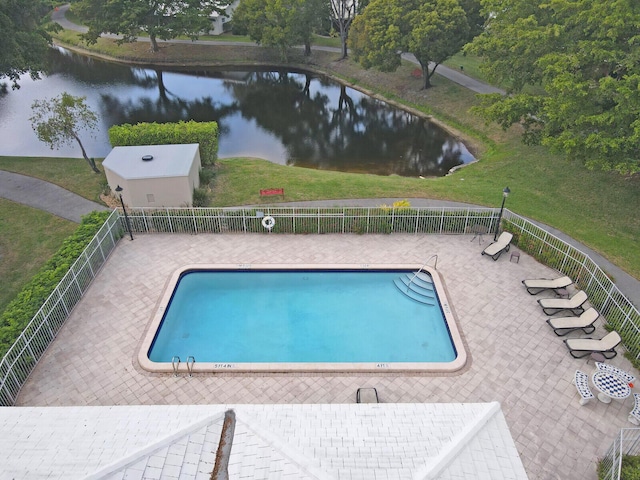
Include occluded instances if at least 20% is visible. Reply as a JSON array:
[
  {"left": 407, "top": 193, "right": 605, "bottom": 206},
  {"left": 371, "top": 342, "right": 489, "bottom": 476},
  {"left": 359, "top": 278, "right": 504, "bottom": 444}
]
[{"left": 413, "top": 402, "right": 501, "bottom": 480}]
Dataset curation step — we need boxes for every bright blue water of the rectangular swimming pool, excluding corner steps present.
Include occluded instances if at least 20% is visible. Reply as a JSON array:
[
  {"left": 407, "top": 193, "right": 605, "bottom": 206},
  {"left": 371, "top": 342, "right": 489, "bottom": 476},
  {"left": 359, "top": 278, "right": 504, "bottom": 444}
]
[{"left": 148, "top": 270, "right": 456, "bottom": 363}]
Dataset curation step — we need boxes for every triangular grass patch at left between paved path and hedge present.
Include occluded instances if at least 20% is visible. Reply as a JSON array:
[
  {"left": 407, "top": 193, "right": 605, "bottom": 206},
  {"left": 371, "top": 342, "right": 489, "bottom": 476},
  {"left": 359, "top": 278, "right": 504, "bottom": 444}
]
[{"left": 0, "top": 198, "right": 77, "bottom": 312}]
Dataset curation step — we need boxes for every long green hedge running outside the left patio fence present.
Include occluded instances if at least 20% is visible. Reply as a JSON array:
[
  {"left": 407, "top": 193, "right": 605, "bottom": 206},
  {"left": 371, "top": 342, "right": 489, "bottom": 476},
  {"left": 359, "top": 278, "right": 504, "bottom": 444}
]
[{"left": 0, "top": 211, "right": 111, "bottom": 358}]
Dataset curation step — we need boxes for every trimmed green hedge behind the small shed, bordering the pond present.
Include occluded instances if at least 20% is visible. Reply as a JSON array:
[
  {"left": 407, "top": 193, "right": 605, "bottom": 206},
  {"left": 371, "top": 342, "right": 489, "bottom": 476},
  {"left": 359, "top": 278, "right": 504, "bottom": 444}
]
[{"left": 109, "top": 120, "right": 218, "bottom": 165}]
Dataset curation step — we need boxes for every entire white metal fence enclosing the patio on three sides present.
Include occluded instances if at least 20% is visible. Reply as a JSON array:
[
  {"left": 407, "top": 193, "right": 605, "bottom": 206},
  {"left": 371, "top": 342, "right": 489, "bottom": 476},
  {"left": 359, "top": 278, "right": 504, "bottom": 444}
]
[{"left": 0, "top": 207, "right": 640, "bottom": 405}]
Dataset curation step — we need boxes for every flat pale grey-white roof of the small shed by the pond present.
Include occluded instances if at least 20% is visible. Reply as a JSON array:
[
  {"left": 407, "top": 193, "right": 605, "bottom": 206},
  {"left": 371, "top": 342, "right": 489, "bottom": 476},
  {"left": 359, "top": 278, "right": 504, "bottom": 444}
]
[{"left": 102, "top": 143, "right": 198, "bottom": 179}]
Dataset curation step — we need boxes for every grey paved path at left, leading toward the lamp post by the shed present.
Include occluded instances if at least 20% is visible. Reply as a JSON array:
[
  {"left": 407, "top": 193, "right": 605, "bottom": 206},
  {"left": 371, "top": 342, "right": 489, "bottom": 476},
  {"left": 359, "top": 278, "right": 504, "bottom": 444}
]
[{"left": 0, "top": 170, "right": 108, "bottom": 223}]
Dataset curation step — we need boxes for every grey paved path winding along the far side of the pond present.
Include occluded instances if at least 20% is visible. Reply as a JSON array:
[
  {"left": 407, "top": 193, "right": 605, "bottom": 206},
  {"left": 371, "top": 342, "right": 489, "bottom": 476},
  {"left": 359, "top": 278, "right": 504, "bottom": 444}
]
[{"left": 51, "top": 5, "right": 505, "bottom": 93}]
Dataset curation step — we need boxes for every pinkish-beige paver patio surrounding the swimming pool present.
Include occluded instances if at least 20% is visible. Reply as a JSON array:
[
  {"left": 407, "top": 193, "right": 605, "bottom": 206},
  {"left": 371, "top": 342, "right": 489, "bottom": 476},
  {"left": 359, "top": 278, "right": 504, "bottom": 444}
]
[{"left": 17, "top": 234, "right": 633, "bottom": 480}]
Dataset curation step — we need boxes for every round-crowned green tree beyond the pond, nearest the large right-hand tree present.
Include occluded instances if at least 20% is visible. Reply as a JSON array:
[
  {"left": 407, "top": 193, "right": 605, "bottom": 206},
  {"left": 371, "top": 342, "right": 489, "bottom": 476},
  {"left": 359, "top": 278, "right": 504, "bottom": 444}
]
[{"left": 351, "top": 0, "right": 470, "bottom": 88}]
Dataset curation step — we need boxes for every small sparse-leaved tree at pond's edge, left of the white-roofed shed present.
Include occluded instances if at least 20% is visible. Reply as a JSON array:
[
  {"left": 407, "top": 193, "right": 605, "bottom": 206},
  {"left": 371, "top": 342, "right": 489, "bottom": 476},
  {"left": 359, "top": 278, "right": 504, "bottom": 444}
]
[{"left": 29, "top": 92, "right": 100, "bottom": 173}]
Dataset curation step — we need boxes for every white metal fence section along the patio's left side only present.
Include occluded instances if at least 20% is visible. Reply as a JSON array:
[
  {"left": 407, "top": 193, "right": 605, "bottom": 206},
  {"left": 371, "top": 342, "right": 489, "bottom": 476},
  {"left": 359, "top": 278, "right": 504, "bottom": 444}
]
[{"left": 0, "top": 211, "right": 122, "bottom": 406}]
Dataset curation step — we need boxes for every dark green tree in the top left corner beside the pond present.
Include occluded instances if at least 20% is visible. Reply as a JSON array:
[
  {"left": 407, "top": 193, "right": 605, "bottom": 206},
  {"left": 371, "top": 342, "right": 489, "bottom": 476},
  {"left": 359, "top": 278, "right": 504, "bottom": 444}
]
[{"left": 0, "top": 0, "right": 54, "bottom": 88}]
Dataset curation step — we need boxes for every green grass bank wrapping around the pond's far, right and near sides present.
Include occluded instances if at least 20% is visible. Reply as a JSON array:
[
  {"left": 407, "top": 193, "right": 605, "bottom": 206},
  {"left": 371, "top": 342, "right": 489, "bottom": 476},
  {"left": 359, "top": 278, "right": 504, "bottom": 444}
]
[{"left": 7, "top": 32, "right": 640, "bottom": 284}]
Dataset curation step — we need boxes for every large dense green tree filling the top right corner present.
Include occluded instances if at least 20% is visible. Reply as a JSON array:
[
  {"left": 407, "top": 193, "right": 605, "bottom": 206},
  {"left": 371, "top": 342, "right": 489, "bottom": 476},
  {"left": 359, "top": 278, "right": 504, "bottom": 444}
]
[{"left": 469, "top": 0, "right": 640, "bottom": 174}]
